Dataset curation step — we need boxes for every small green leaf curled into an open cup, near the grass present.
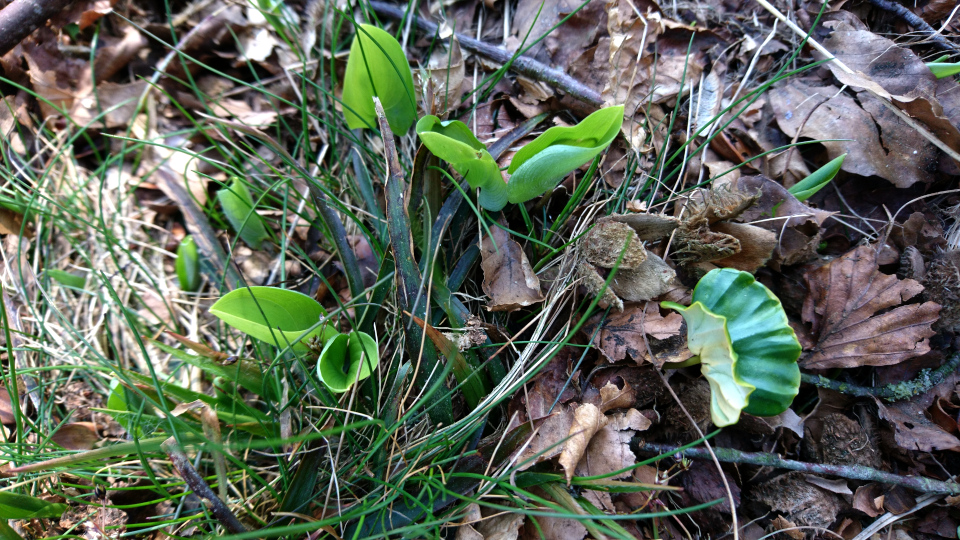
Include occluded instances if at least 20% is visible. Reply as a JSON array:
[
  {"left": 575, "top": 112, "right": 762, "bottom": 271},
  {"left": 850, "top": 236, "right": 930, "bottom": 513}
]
[{"left": 317, "top": 332, "right": 380, "bottom": 394}]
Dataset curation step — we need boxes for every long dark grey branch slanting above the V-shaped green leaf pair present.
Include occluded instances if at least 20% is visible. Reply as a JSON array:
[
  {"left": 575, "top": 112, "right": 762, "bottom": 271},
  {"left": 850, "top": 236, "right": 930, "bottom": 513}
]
[{"left": 369, "top": 0, "right": 603, "bottom": 107}]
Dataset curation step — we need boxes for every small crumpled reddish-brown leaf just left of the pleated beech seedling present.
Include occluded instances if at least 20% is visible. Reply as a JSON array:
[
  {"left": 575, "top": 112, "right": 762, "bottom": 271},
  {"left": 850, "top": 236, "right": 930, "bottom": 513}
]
[{"left": 584, "top": 302, "right": 683, "bottom": 362}]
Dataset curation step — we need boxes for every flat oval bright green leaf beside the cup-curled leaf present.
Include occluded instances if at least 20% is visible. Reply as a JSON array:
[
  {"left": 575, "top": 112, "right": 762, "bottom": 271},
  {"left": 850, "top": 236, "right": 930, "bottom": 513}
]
[{"left": 210, "top": 287, "right": 336, "bottom": 352}]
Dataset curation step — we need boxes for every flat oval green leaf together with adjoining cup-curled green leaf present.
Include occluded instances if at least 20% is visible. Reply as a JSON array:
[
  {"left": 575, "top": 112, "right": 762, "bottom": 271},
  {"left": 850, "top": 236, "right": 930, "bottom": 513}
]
[{"left": 210, "top": 287, "right": 380, "bottom": 393}]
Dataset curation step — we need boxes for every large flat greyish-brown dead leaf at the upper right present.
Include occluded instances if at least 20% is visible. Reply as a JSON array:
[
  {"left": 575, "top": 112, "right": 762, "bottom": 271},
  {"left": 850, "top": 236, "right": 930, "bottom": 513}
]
[{"left": 769, "top": 81, "right": 936, "bottom": 188}]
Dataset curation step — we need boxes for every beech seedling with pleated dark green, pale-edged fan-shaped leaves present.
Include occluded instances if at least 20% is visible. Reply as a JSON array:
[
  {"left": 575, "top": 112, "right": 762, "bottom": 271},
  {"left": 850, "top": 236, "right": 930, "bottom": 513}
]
[{"left": 660, "top": 268, "right": 801, "bottom": 427}]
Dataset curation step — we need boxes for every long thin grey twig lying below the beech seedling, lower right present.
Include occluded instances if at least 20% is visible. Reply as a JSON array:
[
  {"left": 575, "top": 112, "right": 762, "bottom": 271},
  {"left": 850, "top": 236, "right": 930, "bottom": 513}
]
[{"left": 637, "top": 441, "right": 960, "bottom": 493}]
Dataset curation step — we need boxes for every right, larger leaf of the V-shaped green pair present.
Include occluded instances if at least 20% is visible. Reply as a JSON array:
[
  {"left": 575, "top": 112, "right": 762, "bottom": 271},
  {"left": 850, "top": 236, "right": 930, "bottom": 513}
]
[{"left": 507, "top": 105, "right": 623, "bottom": 203}]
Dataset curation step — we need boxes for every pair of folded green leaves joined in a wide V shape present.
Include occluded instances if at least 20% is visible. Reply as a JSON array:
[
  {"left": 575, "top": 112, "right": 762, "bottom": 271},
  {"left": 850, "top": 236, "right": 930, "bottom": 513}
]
[{"left": 417, "top": 105, "right": 623, "bottom": 211}]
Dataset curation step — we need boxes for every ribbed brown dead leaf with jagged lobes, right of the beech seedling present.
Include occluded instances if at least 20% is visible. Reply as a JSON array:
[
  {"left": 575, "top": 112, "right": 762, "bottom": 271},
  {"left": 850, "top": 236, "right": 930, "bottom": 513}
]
[{"left": 801, "top": 246, "right": 940, "bottom": 369}]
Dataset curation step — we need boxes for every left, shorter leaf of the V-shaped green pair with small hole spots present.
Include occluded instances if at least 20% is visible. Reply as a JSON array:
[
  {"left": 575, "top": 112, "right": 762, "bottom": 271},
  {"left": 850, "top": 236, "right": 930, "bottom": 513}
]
[{"left": 417, "top": 115, "right": 507, "bottom": 212}]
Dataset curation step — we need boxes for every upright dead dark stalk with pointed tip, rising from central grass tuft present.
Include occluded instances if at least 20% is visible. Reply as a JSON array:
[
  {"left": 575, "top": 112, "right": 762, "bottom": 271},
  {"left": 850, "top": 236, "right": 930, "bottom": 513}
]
[{"left": 373, "top": 98, "right": 453, "bottom": 426}]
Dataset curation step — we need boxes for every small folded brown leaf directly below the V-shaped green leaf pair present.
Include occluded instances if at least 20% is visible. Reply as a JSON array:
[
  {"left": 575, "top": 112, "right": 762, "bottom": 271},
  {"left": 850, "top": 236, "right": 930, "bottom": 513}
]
[{"left": 480, "top": 220, "right": 543, "bottom": 311}]
